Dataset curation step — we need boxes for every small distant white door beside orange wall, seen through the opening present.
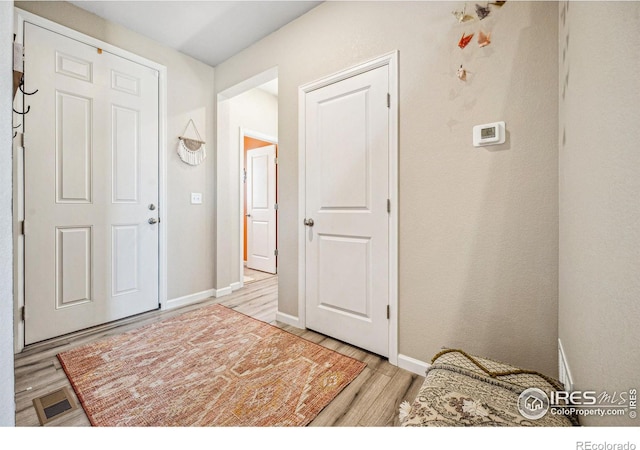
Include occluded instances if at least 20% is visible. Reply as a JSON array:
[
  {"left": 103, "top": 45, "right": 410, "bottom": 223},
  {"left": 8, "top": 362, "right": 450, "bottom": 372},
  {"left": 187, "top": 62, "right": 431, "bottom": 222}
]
[{"left": 246, "top": 145, "right": 276, "bottom": 273}]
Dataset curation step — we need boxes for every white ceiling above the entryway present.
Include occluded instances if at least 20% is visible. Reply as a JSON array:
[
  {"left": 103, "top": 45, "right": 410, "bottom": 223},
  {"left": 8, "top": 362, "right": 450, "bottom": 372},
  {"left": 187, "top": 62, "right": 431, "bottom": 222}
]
[{"left": 70, "top": 0, "right": 322, "bottom": 66}]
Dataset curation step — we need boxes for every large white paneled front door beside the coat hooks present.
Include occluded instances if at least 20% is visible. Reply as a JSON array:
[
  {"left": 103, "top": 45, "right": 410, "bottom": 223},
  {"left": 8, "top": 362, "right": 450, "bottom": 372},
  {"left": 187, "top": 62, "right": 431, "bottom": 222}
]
[{"left": 24, "top": 23, "right": 159, "bottom": 344}]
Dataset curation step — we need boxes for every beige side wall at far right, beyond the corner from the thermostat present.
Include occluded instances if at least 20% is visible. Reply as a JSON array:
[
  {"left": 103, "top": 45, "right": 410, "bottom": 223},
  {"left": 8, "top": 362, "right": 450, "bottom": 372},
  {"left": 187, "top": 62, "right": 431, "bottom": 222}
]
[{"left": 559, "top": 2, "right": 640, "bottom": 426}]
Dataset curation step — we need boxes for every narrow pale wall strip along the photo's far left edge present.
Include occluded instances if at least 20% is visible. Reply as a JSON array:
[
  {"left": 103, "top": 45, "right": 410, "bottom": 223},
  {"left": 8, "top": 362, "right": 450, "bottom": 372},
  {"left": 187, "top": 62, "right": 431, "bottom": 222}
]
[{"left": 0, "top": 1, "right": 15, "bottom": 427}]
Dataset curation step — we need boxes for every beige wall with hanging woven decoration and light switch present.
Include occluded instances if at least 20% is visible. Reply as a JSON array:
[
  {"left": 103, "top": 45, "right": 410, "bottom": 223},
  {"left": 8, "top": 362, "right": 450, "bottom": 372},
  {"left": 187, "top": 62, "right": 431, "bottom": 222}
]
[{"left": 16, "top": 1, "right": 215, "bottom": 299}]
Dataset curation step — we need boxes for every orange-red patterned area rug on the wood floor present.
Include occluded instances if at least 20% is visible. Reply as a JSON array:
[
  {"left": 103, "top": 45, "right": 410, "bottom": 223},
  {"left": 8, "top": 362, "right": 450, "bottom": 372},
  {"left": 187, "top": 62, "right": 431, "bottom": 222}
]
[{"left": 58, "top": 305, "right": 365, "bottom": 427}]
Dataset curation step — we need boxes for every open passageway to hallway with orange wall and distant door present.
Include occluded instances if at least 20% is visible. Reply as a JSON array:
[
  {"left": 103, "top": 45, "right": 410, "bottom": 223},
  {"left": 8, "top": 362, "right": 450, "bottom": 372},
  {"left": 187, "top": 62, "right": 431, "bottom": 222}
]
[{"left": 216, "top": 68, "right": 278, "bottom": 297}]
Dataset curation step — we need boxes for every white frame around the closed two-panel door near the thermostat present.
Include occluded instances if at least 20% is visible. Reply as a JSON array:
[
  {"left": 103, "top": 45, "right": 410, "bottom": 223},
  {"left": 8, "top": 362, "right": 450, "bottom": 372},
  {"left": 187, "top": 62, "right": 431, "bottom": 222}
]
[{"left": 296, "top": 50, "right": 399, "bottom": 366}]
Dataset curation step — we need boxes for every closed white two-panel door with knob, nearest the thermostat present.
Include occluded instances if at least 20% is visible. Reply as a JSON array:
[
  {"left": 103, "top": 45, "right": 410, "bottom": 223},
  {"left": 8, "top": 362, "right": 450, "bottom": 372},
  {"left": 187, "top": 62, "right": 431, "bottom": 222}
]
[{"left": 304, "top": 66, "right": 390, "bottom": 356}]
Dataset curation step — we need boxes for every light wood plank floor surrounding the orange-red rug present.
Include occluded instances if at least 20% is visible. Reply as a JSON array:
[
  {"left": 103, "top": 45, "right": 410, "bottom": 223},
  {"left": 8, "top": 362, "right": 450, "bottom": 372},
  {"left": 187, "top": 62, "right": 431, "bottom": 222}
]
[{"left": 15, "top": 276, "right": 424, "bottom": 427}]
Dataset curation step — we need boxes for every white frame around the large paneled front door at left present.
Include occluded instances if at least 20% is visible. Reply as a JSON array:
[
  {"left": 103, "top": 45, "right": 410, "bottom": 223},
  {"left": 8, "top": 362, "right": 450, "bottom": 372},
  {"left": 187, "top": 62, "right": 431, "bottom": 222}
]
[{"left": 13, "top": 8, "right": 168, "bottom": 353}]
